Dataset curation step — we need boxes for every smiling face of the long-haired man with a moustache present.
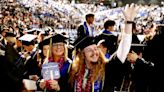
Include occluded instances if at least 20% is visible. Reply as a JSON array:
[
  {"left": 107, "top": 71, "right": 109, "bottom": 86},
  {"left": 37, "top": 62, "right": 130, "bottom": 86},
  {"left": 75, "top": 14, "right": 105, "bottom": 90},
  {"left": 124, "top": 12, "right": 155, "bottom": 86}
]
[{"left": 83, "top": 44, "right": 99, "bottom": 62}]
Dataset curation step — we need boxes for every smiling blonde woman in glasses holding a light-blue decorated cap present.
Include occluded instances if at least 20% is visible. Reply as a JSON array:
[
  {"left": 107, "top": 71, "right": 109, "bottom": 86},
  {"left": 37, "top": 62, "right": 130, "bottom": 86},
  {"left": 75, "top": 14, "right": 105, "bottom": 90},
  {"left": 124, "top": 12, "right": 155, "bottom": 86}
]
[{"left": 37, "top": 34, "right": 72, "bottom": 92}]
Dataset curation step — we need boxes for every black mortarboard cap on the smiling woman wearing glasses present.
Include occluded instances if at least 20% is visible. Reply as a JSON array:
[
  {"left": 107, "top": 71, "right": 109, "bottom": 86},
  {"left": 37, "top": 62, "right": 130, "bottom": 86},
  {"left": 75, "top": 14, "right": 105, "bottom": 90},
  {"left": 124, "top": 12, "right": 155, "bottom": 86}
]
[{"left": 52, "top": 34, "right": 68, "bottom": 43}]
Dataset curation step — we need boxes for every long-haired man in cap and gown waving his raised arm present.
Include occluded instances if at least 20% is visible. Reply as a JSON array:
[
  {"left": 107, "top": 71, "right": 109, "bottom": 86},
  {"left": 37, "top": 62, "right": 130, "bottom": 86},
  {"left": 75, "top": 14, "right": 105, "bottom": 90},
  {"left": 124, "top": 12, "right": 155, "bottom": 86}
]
[{"left": 70, "top": 4, "right": 138, "bottom": 92}]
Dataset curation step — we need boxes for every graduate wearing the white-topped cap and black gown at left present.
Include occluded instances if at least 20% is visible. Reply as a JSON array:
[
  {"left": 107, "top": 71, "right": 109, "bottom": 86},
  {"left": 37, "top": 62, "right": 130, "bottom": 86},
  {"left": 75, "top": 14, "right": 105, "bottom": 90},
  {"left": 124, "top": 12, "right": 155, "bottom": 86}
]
[{"left": 19, "top": 34, "right": 40, "bottom": 81}]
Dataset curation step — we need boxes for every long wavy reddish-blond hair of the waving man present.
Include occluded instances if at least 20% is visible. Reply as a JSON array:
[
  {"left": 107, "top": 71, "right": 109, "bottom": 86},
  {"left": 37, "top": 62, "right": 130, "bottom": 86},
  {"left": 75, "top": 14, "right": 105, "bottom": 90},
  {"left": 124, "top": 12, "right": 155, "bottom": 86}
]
[{"left": 70, "top": 49, "right": 105, "bottom": 87}]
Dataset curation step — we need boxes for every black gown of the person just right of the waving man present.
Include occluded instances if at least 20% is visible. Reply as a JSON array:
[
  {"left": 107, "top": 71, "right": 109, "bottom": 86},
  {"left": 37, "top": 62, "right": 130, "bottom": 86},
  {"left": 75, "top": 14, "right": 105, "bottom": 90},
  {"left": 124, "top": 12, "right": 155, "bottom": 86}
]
[{"left": 123, "top": 59, "right": 153, "bottom": 92}]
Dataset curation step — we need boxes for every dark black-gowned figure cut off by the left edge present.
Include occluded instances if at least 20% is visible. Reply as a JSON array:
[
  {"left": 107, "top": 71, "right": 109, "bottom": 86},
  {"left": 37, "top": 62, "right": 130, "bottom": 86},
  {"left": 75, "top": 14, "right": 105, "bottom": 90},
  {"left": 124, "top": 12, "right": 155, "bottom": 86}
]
[{"left": 0, "top": 45, "right": 23, "bottom": 92}]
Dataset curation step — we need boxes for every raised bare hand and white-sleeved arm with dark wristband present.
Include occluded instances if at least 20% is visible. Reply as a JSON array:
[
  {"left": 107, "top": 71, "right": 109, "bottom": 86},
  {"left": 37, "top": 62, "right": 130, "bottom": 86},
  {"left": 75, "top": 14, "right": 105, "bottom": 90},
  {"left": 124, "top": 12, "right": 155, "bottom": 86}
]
[{"left": 117, "top": 4, "right": 139, "bottom": 63}]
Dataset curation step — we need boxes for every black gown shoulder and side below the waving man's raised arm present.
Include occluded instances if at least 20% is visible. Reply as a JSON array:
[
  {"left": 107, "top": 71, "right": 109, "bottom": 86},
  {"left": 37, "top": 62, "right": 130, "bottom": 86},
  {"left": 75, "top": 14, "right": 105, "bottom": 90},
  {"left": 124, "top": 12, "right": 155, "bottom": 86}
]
[{"left": 103, "top": 56, "right": 124, "bottom": 92}]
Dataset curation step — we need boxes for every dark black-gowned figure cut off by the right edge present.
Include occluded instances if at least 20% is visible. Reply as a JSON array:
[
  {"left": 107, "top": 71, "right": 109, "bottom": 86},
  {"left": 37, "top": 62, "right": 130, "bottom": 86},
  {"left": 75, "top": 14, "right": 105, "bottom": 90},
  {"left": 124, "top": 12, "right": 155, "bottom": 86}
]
[{"left": 143, "top": 30, "right": 164, "bottom": 92}]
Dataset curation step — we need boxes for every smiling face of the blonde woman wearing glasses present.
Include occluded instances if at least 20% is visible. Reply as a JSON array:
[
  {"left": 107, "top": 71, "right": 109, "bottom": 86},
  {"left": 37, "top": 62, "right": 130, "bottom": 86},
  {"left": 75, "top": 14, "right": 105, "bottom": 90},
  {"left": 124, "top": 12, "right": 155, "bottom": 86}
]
[{"left": 52, "top": 42, "right": 64, "bottom": 56}]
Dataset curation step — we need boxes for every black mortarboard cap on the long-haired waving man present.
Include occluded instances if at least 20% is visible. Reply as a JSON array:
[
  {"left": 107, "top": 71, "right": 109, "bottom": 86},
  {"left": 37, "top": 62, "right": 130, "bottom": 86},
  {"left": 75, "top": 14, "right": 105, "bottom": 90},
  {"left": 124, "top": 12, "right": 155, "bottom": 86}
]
[{"left": 74, "top": 36, "right": 98, "bottom": 50}]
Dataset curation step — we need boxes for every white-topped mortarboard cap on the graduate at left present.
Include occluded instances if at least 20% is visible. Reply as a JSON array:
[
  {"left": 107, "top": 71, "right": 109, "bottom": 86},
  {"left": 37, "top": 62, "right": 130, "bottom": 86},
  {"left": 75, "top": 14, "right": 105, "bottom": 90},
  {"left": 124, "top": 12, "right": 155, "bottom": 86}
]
[{"left": 19, "top": 34, "right": 37, "bottom": 46}]
